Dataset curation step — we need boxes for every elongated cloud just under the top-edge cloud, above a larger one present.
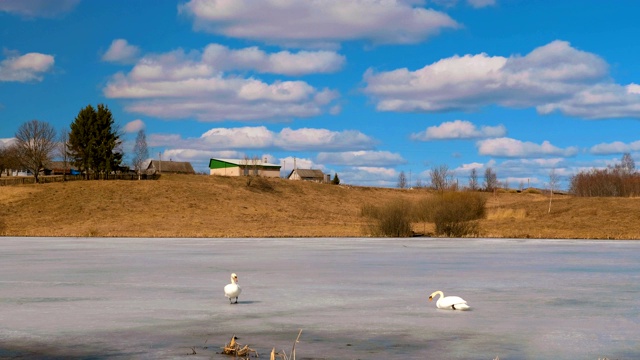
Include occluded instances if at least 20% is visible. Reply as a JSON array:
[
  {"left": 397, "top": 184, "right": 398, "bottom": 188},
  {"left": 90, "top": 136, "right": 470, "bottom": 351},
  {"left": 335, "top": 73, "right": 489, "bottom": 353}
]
[{"left": 202, "top": 44, "right": 346, "bottom": 76}]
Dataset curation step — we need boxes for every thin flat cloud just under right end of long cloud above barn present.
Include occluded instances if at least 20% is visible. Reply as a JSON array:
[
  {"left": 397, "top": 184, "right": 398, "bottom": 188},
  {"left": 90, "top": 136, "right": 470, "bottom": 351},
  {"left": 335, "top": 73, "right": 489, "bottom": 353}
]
[{"left": 317, "top": 150, "right": 406, "bottom": 167}]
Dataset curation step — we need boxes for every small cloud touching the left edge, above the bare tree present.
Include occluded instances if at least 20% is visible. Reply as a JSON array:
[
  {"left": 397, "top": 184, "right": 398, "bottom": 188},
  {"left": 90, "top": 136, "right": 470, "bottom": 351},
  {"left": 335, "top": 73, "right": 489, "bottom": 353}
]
[{"left": 0, "top": 53, "right": 55, "bottom": 82}]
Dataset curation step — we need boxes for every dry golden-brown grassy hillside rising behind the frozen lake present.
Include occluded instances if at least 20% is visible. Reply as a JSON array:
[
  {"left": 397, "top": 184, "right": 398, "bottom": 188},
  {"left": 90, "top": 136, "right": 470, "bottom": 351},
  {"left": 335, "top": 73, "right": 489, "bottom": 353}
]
[{"left": 0, "top": 175, "right": 640, "bottom": 239}]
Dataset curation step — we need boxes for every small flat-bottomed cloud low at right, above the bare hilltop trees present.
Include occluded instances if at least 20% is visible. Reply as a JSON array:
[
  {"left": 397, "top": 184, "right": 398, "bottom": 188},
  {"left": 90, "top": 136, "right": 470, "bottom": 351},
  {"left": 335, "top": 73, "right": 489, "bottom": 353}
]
[{"left": 477, "top": 137, "right": 578, "bottom": 158}]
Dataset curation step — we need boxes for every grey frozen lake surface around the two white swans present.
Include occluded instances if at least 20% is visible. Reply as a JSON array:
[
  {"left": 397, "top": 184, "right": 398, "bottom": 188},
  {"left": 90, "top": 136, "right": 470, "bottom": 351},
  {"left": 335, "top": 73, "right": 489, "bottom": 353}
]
[{"left": 0, "top": 237, "right": 640, "bottom": 360}]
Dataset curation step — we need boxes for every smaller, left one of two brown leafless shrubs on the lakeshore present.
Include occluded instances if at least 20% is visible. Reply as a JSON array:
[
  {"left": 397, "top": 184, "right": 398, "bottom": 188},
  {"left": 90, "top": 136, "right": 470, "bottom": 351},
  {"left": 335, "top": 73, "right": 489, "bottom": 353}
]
[{"left": 360, "top": 199, "right": 413, "bottom": 237}]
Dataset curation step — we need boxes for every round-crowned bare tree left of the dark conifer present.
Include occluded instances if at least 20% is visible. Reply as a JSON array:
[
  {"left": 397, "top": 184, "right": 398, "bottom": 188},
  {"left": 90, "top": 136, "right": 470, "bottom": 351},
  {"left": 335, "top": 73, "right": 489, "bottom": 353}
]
[{"left": 16, "top": 120, "right": 56, "bottom": 183}]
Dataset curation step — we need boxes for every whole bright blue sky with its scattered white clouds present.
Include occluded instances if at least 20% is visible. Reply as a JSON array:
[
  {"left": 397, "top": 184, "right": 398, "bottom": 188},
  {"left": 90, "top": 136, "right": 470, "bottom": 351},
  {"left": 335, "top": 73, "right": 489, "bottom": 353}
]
[{"left": 0, "top": 0, "right": 640, "bottom": 188}]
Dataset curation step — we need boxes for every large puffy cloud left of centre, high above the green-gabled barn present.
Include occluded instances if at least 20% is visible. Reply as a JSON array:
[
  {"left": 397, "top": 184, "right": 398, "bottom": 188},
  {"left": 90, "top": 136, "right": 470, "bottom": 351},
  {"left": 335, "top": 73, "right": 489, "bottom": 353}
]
[{"left": 103, "top": 45, "right": 338, "bottom": 121}]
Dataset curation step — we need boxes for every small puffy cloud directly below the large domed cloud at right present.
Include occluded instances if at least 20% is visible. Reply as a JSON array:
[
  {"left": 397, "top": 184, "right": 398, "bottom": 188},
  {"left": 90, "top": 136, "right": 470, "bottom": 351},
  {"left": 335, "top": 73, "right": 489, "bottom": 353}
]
[{"left": 411, "top": 120, "right": 507, "bottom": 141}]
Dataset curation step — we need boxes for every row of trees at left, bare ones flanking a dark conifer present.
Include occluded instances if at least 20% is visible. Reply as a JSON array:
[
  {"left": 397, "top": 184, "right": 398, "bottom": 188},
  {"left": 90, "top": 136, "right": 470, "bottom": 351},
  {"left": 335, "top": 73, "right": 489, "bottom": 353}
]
[{"left": 0, "top": 104, "right": 148, "bottom": 182}]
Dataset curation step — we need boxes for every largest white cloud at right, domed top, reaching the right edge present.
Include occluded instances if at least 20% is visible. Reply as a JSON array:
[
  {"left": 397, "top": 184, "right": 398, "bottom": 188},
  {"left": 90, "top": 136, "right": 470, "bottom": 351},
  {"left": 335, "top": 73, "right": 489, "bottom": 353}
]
[{"left": 364, "top": 41, "right": 640, "bottom": 119}]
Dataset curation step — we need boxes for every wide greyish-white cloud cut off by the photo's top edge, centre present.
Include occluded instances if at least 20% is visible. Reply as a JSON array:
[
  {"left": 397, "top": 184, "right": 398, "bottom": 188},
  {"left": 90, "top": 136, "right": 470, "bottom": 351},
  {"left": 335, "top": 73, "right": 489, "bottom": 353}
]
[{"left": 179, "top": 0, "right": 459, "bottom": 47}]
